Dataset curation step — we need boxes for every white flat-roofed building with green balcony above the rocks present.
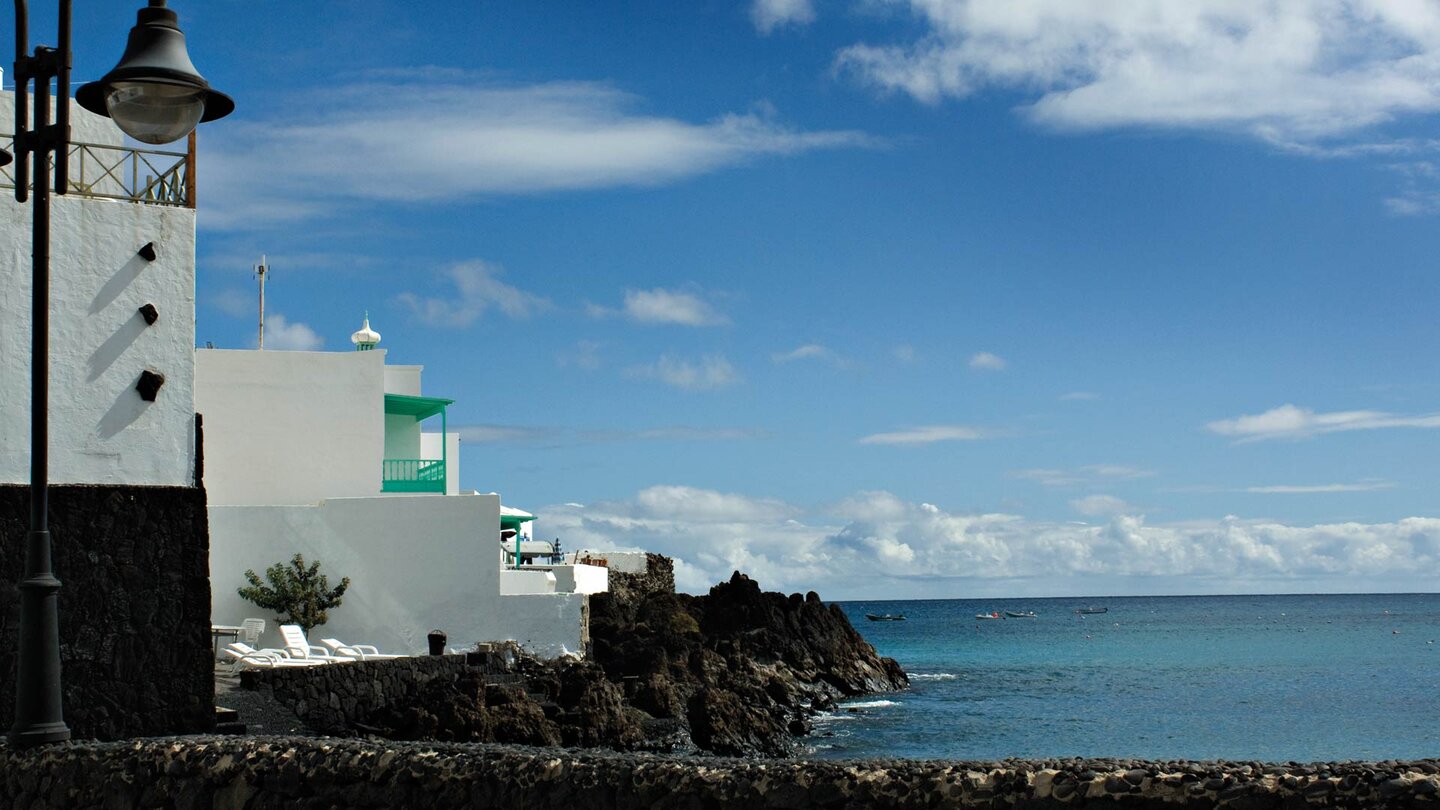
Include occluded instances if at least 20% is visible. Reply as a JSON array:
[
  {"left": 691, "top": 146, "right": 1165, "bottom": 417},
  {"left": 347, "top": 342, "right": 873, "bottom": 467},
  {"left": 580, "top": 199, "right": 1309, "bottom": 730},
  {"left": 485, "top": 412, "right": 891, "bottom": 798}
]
[{"left": 196, "top": 319, "right": 606, "bottom": 656}]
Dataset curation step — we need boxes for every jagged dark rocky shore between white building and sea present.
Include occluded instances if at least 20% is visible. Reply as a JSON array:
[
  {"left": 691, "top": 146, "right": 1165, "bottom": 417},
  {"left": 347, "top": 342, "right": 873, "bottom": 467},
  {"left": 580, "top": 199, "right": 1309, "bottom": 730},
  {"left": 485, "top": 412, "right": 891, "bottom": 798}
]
[{"left": 325, "top": 558, "right": 909, "bottom": 757}]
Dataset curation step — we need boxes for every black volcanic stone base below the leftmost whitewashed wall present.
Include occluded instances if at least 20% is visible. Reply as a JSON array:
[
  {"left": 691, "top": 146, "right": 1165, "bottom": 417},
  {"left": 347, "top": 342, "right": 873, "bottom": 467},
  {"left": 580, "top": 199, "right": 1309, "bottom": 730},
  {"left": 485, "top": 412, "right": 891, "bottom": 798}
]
[{"left": 0, "top": 486, "right": 215, "bottom": 739}]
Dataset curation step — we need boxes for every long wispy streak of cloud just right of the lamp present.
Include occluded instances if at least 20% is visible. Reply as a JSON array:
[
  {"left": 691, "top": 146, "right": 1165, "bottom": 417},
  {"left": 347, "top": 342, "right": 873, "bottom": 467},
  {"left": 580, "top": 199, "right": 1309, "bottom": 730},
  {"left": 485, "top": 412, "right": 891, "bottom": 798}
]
[{"left": 200, "top": 69, "right": 873, "bottom": 228}]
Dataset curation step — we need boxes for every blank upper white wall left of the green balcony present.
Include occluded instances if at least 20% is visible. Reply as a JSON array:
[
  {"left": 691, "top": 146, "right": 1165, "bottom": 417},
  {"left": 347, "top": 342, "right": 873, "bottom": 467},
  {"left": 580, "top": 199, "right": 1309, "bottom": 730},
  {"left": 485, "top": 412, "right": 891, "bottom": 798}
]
[{"left": 194, "top": 349, "right": 384, "bottom": 506}]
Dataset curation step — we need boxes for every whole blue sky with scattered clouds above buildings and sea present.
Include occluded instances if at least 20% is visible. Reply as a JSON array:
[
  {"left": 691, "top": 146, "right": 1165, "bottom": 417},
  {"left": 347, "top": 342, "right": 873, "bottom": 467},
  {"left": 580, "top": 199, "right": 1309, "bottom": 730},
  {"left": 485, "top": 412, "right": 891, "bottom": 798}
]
[{"left": 22, "top": 0, "right": 1440, "bottom": 598}]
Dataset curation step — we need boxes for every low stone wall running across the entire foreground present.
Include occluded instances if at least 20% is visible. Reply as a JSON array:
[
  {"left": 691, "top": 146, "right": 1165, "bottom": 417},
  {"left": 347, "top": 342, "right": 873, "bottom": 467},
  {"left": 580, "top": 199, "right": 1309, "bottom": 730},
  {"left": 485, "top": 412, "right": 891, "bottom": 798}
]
[{"left": 0, "top": 736, "right": 1440, "bottom": 810}]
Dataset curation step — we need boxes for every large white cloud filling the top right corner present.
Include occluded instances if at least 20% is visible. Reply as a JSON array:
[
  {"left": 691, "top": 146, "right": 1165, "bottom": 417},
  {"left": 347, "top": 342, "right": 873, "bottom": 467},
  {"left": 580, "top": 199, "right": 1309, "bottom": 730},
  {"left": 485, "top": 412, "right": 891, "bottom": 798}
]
[{"left": 837, "top": 0, "right": 1440, "bottom": 140}]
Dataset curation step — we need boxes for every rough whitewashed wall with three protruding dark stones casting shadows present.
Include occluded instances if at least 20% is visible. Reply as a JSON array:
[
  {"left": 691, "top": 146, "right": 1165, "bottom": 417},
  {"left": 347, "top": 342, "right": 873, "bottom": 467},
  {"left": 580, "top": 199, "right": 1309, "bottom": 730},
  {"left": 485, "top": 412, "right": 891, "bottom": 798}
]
[{"left": 0, "top": 92, "right": 194, "bottom": 486}]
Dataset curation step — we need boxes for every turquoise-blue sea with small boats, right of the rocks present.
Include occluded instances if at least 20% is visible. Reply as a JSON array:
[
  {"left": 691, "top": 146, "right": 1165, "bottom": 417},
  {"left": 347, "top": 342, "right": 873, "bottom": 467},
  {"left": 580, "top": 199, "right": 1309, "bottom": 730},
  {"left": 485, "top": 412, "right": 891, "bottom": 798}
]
[{"left": 811, "top": 594, "right": 1440, "bottom": 762}]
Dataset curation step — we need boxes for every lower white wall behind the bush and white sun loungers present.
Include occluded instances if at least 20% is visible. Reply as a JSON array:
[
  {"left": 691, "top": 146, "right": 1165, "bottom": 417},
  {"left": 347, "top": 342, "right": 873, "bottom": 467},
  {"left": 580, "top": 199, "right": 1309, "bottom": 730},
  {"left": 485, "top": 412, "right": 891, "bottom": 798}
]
[{"left": 210, "top": 490, "right": 501, "bottom": 653}]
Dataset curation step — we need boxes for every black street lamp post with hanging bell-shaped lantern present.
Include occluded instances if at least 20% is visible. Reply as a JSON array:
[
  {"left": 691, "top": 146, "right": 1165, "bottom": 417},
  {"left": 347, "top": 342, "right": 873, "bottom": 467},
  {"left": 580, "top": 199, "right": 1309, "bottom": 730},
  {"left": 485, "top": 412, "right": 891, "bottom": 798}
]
[{"left": 10, "top": 0, "right": 235, "bottom": 748}]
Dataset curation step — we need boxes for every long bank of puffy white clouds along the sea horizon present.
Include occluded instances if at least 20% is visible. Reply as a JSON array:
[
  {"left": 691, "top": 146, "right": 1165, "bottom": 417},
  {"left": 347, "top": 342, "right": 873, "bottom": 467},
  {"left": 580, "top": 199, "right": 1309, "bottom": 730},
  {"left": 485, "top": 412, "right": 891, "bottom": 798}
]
[{"left": 539, "top": 487, "right": 1440, "bottom": 598}]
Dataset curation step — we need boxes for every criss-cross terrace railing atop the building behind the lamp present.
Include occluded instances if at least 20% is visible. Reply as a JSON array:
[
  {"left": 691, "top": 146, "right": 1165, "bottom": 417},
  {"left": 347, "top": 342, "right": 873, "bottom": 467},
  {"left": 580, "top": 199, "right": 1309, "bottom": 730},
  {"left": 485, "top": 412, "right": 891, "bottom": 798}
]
[{"left": 0, "top": 134, "right": 194, "bottom": 208}]
